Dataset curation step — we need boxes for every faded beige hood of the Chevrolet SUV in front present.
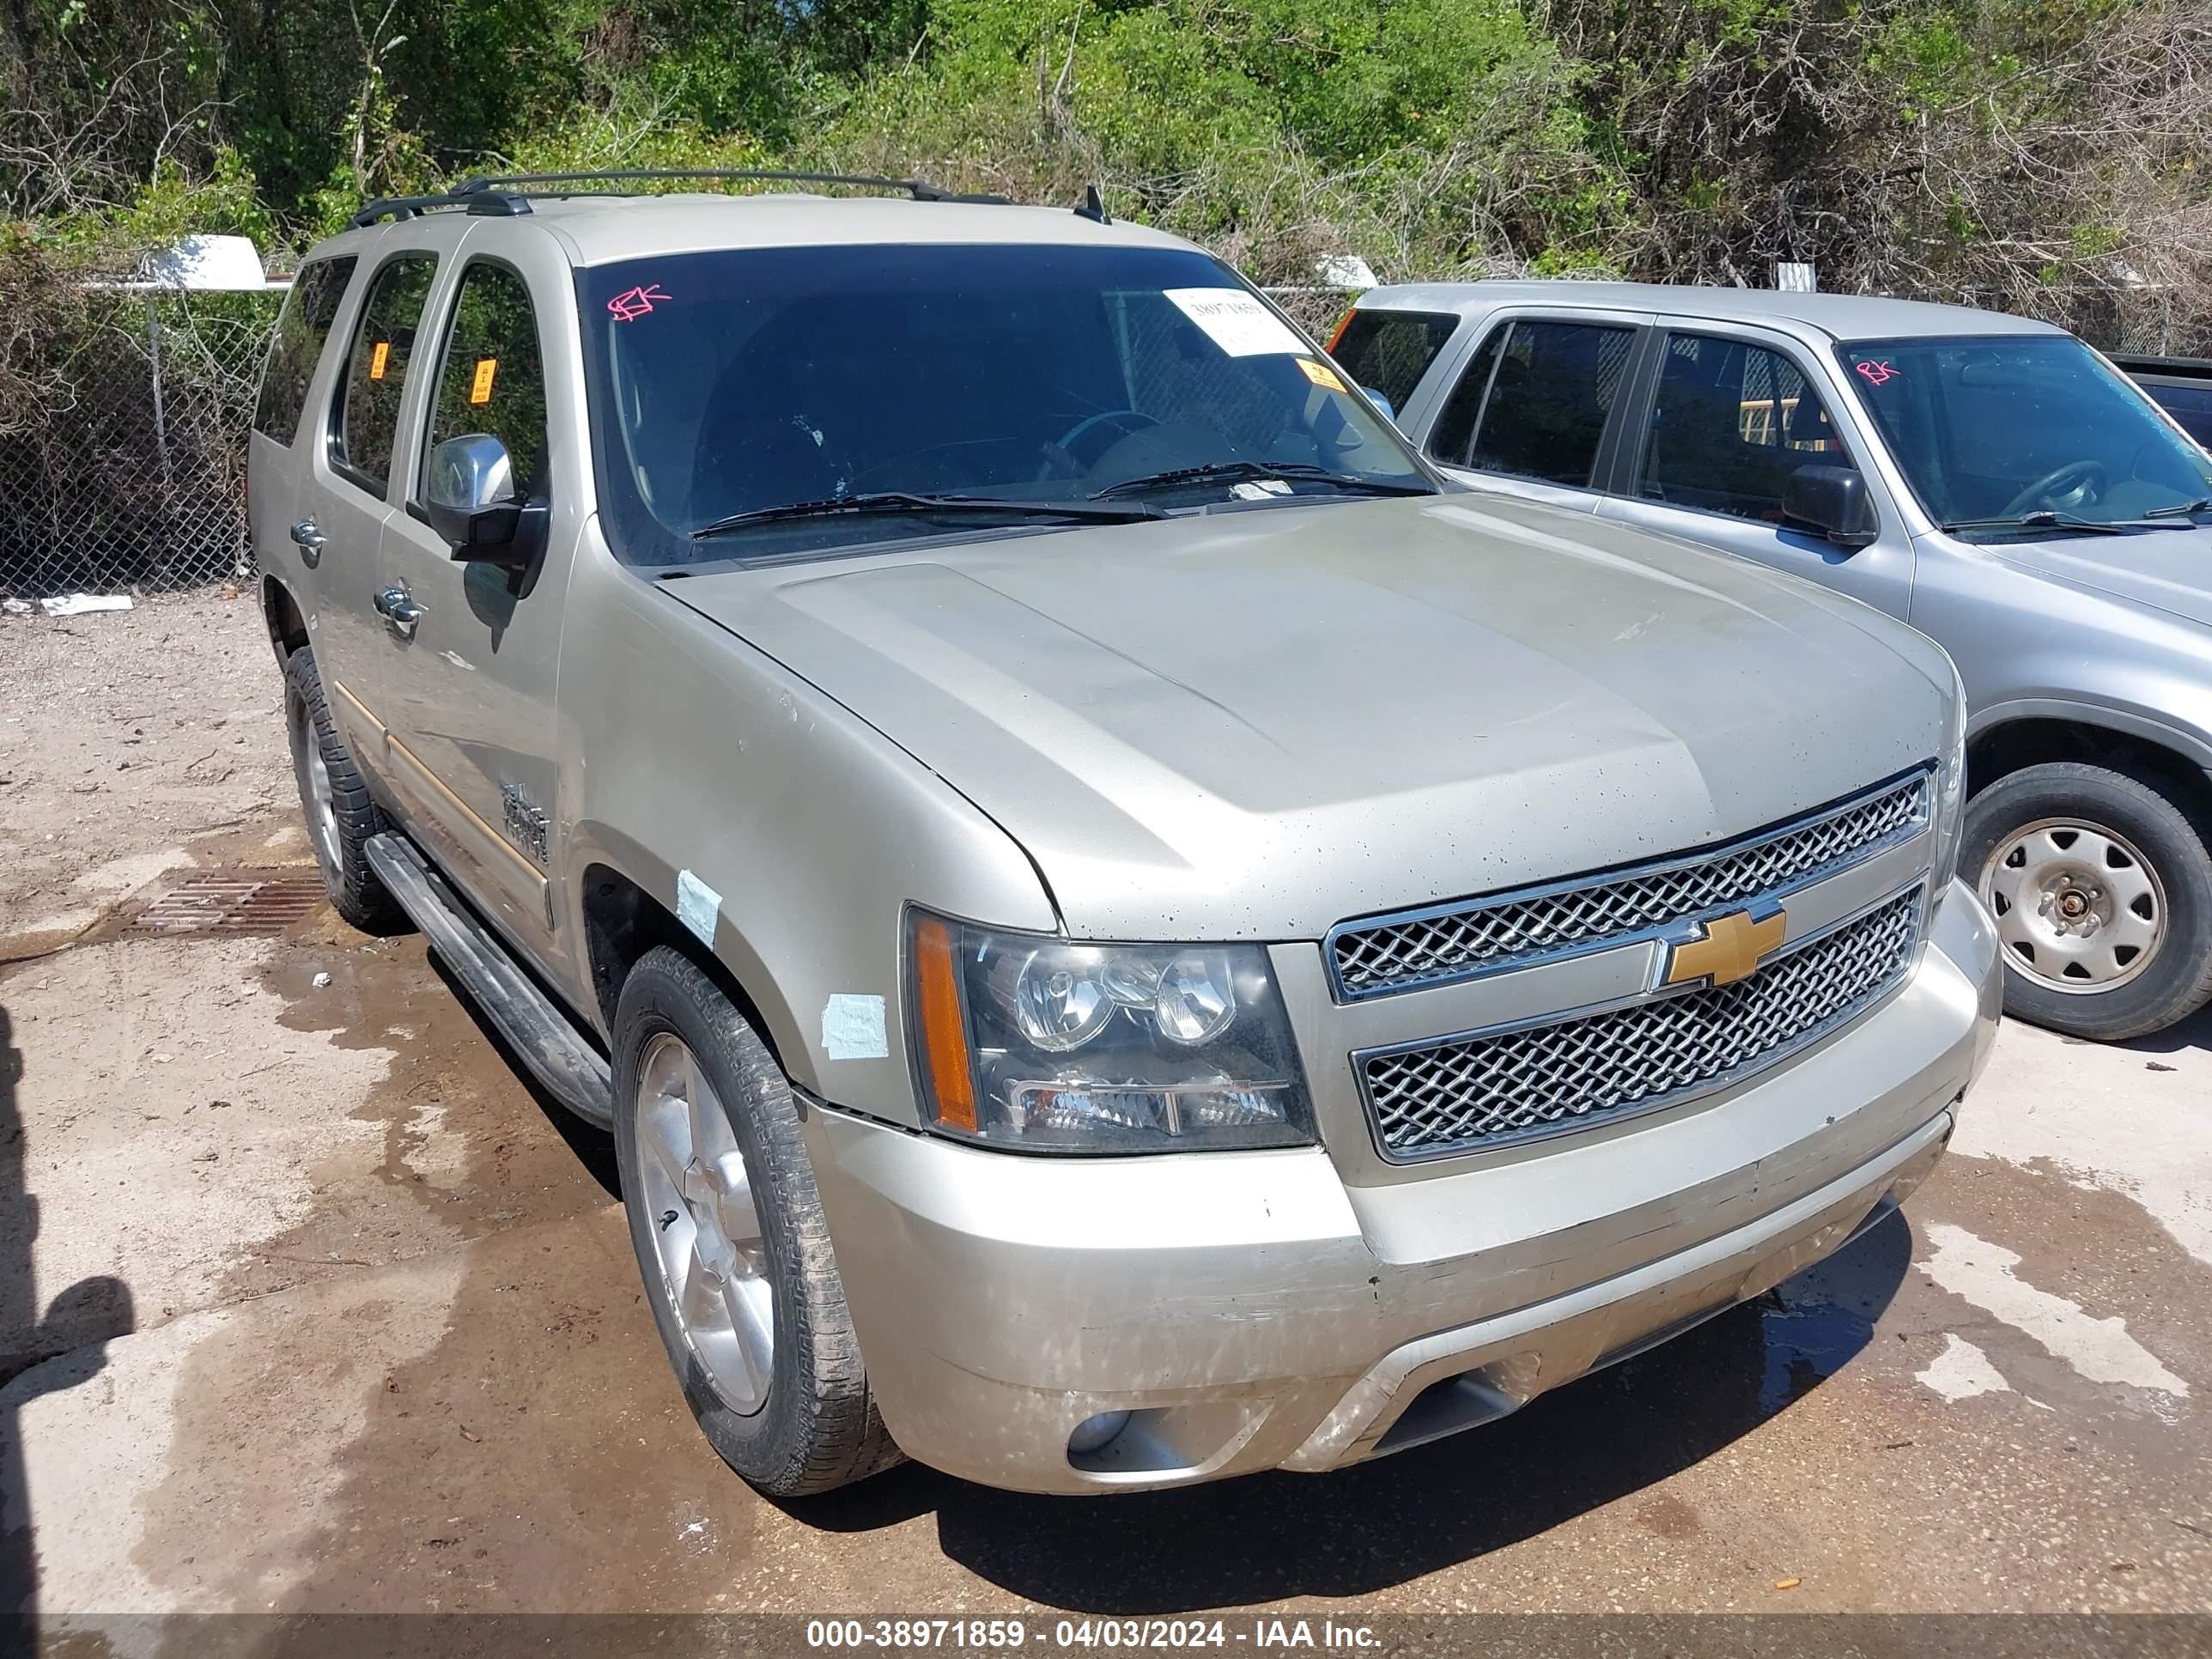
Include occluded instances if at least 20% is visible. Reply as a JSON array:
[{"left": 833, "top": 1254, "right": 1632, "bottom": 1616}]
[{"left": 664, "top": 495, "right": 1951, "bottom": 940}]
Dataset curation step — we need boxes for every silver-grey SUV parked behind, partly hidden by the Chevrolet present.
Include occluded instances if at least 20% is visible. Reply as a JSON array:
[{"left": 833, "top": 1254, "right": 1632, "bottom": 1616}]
[{"left": 1336, "top": 283, "right": 2212, "bottom": 1040}]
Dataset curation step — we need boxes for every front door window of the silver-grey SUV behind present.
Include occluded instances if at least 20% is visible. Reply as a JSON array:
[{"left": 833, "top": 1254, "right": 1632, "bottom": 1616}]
[{"left": 1637, "top": 334, "right": 1854, "bottom": 525}]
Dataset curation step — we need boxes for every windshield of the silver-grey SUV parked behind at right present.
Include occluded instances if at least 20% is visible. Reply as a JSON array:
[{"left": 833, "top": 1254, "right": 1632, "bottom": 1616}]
[{"left": 1836, "top": 334, "right": 2212, "bottom": 535}]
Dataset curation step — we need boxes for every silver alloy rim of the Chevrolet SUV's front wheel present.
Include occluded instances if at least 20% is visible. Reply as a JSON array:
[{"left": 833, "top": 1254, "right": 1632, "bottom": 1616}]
[{"left": 630, "top": 1030, "right": 776, "bottom": 1416}]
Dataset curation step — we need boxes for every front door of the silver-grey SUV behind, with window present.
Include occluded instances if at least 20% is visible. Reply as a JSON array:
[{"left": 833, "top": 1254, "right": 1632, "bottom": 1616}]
[{"left": 1601, "top": 323, "right": 1913, "bottom": 617}]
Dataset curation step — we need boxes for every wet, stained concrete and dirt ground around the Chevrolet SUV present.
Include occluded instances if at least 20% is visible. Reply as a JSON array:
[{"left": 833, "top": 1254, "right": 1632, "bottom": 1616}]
[{"left": 0, "top": 595, "right": 2212, "bottom": 1654}]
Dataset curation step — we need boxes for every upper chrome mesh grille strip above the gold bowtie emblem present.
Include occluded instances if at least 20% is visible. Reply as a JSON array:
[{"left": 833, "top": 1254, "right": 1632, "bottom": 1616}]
[{"left": 1329, "top": 772, "right": 1929, "bottom": 1002}]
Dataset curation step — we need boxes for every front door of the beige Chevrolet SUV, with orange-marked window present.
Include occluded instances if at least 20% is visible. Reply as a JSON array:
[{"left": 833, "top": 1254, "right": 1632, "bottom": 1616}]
[{"left": 383, "top": 226, "right": 584, "bottom": 969}]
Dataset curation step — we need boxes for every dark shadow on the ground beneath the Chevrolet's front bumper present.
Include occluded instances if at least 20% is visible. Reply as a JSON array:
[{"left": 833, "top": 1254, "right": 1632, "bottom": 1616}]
[{"left": 787, "top": 1217, "right": 1911, "bottom": 1614}]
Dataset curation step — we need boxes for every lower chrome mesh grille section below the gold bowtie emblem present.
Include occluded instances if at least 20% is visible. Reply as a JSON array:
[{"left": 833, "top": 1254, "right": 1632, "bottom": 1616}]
[{"left": 1356, "top": 887, "right": 1923, "bottom": 1159}]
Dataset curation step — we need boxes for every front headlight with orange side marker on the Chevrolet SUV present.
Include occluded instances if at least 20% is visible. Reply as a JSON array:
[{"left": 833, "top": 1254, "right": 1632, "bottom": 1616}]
[{"left": 907, "top": 911, "right": 1314, "bottom": 1152}]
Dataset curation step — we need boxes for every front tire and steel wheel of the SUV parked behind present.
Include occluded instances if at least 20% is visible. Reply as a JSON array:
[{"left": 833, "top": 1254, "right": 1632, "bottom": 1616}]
[{"left": 1960, "top": 761, "right": 2212, "bottom": 1042}]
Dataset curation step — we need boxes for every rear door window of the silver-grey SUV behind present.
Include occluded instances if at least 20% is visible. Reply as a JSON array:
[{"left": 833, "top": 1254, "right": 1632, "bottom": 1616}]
[{"left": 1431, "top": 319, "right": 1635, "bottom": 489}]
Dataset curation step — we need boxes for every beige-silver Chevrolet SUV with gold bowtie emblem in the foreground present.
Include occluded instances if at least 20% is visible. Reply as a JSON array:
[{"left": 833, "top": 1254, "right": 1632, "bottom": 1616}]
[{"left": 252, "top": 179, "right": 1997, "bottom": 1493}]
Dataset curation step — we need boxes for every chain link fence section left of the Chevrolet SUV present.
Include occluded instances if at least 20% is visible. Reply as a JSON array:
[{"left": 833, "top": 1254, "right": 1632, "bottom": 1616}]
[{"left": 0, "top": 288, "right": 283, "bottom": 598}]
